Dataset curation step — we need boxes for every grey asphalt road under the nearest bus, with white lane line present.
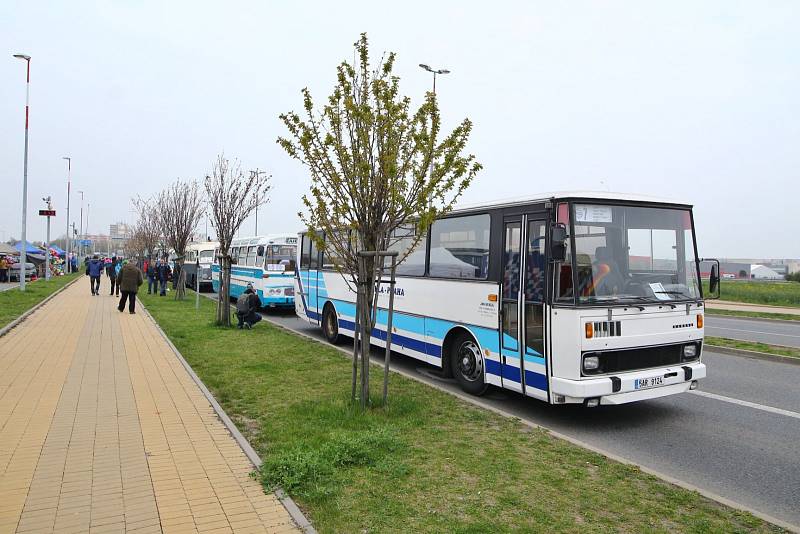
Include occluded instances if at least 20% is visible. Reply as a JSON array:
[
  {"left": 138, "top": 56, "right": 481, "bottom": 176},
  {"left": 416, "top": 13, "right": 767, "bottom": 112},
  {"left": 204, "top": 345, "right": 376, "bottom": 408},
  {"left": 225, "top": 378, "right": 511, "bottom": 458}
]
[{"left": 264, "top": 312, "right": 800, "bottom": 529}]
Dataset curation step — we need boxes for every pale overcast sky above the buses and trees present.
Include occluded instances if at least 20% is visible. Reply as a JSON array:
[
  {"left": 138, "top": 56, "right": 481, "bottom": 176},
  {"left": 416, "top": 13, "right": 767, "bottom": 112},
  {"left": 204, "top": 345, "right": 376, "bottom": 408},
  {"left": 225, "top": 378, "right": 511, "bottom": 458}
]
[{"left": 0, "top": 0, "right": 800, "bottom": 257}]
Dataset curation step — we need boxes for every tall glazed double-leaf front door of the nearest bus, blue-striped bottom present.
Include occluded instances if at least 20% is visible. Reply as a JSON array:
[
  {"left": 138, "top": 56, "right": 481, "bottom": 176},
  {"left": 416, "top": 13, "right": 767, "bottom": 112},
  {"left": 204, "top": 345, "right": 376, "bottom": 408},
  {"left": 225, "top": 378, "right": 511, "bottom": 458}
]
[{"left": 500, "top": 214, "right": 547, "bottom": 399}]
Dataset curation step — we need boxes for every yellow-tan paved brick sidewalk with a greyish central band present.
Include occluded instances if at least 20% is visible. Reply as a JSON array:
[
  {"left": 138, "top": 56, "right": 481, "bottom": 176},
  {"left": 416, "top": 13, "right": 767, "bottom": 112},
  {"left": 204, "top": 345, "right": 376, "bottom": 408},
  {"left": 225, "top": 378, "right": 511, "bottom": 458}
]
[{"left": 0, "top": 282, "right": 297, "bottom": 533}]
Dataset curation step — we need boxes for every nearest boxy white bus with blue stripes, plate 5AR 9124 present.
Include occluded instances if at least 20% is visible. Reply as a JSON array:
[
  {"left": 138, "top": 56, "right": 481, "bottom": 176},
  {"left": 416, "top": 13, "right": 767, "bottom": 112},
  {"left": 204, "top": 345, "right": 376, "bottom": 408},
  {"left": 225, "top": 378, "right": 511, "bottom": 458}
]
[{"left": 295, "top": 192, "right": 718, "bottom": 406}]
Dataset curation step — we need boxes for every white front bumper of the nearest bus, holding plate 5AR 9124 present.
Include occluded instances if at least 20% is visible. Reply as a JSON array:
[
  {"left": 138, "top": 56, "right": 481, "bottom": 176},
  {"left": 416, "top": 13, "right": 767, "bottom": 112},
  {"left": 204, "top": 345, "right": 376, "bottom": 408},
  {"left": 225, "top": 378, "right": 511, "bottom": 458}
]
[{"left": 550, "top": 362, "right": 706, "bottom": 404}]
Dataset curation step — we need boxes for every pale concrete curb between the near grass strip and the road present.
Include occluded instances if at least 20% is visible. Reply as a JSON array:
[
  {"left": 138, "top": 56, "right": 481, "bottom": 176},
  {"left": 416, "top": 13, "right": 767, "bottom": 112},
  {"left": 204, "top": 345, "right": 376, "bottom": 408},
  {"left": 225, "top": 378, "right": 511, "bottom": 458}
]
[{"left": 262, "top": 314, "right": 800, "bottom": 533}]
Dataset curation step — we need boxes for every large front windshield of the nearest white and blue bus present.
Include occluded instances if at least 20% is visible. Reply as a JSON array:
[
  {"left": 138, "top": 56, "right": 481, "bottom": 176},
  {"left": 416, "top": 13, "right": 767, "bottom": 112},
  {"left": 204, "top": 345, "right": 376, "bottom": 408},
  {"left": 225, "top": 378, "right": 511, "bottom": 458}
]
[{"left": 572, "top": 204, "right": 700, "bottom": 304}]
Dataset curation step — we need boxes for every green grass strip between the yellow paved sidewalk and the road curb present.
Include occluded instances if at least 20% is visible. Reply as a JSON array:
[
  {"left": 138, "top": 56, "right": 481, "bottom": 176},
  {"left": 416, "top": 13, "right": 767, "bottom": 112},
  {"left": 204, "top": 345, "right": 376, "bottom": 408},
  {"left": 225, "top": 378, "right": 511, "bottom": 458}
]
[{"left": 142, "top": 292, "right": 780, "bottom": 533}]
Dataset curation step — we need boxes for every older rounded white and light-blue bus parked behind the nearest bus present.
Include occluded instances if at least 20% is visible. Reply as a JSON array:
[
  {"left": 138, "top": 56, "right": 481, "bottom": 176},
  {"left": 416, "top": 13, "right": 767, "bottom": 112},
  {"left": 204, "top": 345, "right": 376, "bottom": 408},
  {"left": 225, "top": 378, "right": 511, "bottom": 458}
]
[{"left": 211, "top": 234, "right": 297, "bottom": 309}]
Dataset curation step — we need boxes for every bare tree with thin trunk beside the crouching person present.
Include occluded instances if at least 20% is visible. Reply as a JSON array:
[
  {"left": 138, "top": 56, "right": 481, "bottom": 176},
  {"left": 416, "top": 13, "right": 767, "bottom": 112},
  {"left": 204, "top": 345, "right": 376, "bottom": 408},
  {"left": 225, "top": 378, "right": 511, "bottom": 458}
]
[{"left": 205, "top": 154, "right": 272, "bottom": 326}]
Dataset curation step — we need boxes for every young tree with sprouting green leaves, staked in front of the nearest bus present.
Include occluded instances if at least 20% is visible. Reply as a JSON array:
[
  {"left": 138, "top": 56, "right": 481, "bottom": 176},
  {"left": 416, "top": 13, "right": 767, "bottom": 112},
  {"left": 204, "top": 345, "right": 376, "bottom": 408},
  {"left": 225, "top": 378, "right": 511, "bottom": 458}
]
[{"left": 278, "top": 34, "right": 481, "bottom": 405}]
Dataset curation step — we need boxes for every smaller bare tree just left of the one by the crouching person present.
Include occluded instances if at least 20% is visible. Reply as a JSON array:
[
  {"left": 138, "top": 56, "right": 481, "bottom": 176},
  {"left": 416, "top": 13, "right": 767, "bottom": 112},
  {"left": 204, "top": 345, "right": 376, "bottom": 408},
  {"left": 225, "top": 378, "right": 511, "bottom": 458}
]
[{"left": 154, "top": 180, "right": 205, "bottom": 300}]
